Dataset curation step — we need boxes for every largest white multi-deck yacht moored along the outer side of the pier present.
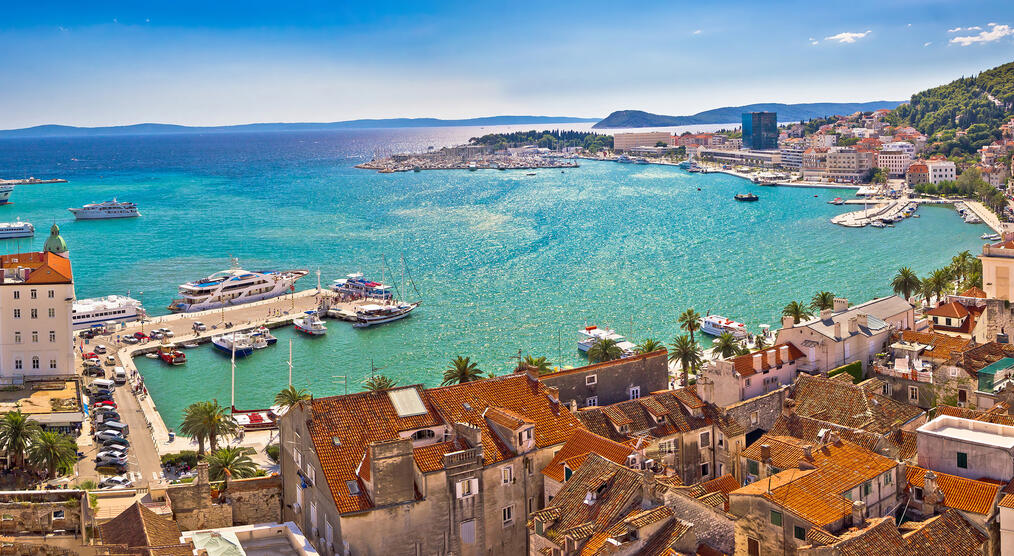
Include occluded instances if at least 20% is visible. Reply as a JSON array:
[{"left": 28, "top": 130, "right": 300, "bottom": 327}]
[{"left": 168, "top": 259, "right": 308, "bottom": 312}]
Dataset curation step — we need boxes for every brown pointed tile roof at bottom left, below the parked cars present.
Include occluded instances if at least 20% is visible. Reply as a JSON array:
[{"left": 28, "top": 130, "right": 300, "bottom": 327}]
[{"left": 98, "top": 502, "right": 194, "bottom": 556}]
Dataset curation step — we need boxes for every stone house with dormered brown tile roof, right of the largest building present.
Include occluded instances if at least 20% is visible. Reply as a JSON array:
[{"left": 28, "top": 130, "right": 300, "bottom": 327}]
[{"left": 577, "top": 388, "right": 746, "bottom": 484}]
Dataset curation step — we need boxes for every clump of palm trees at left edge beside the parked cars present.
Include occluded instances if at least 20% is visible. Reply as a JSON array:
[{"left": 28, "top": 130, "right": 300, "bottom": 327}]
[{"left": 0, "top": 409, "right": 77, "bottom": 478}]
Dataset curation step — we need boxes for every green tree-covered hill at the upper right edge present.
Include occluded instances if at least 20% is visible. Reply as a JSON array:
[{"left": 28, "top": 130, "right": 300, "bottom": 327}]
[{"left": 887, "top": 62, "right": 1014, "bottom": 156}]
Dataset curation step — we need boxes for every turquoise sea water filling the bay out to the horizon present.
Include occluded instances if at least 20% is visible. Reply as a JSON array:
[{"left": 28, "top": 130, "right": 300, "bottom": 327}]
[{"left": 0, "top": 129, "right": 987, "bottom": 426}]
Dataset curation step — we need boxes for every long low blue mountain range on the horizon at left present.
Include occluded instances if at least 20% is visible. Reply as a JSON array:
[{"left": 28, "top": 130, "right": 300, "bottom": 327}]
[{"left": 0, "top": 116, "right": 598, "bottom": 137}]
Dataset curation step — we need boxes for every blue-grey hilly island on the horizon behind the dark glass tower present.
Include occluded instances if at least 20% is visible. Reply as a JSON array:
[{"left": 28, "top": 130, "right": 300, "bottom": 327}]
[{"left": 591, "top": 100, "right": 903, "bottom": 129}]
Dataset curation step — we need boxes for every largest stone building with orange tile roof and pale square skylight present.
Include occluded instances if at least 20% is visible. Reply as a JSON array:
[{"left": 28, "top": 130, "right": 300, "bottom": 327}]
[{"left": 280, "top": 370, "right": 584, "bottom": 556}]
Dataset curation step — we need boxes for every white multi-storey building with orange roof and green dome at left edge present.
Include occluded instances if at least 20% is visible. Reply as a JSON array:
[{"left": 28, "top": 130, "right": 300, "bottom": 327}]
[{"left": 0, "top": 225, "right": 75, "bottom": 377}]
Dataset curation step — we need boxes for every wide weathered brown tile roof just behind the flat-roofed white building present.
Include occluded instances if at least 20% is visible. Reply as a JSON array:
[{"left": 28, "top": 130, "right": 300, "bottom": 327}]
[{"left": 792, "top": 374, "right": 924, "bottom": 434}]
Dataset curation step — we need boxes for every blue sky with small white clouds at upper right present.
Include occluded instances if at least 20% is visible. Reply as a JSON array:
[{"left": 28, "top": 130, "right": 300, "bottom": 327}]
[{"left": 0, "top": 0, "right": 1014, "bottom": 129}]
